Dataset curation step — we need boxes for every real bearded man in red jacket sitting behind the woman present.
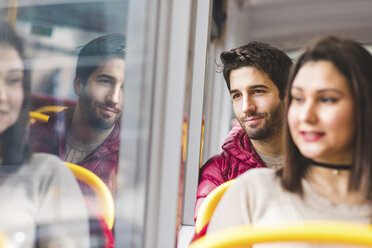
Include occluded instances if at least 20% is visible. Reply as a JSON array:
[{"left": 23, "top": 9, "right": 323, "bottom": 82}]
[{"left": 194, "top": 42, "right": 292, "bottom": 219}]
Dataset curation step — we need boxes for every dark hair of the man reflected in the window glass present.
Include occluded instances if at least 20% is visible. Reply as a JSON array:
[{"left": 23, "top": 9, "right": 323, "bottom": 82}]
[{"left": 76, "top": 34, "right": 125, "bottom": 85}]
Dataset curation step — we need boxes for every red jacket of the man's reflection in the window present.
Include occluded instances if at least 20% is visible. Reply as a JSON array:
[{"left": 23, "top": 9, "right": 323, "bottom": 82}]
[{"left": 30, "top": 108, "right": 120, "bottom": 194}]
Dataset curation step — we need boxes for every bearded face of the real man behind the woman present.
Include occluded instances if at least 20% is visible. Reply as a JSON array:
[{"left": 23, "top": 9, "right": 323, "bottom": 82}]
[{"left": 230, "top": 66, "right": 284, "bottom": 140}]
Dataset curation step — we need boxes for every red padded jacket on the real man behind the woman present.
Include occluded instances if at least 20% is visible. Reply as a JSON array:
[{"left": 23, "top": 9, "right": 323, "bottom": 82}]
[{"left": 194, "top": 121, "right": 266, "bottom": 220}]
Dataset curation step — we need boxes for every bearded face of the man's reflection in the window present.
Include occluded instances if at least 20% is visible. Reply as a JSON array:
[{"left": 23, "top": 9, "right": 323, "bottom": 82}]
[{"left": 75, "top": 58, "right": 125, "bottom": 130}]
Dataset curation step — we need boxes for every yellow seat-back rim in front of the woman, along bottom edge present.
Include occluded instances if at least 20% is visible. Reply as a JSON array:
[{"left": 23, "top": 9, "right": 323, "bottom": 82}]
[{"left": 189, "top": 221, "right": 372, "bottom": 248}]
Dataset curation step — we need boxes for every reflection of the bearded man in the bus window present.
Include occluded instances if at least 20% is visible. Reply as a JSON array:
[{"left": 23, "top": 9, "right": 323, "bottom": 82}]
[{"left": 30, "top": 34, "right": 125, "bottom": 193}]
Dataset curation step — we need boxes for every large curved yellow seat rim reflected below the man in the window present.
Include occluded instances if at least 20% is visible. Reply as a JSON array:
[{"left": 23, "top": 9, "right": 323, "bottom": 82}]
[{"left": 64, "top": 162, "right": 115, "bottom": 230}]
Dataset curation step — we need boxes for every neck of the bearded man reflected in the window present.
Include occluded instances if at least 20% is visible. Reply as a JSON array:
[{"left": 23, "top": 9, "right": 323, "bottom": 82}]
[{"left": 69, "top": 108, "right": 114, "bottom": 145}]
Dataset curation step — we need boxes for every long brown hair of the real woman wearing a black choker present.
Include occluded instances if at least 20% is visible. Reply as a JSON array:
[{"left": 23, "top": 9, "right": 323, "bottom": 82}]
[{"left": 278, "top": 36, "right": 372, "bottom": 199}]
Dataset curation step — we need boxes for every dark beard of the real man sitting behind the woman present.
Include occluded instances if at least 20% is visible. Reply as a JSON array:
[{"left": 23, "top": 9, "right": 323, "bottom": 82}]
[{"left": 239, "top": 102, "right": 284, "bottom": 140}]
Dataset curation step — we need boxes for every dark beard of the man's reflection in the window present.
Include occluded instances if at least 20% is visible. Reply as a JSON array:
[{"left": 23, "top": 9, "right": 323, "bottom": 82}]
[{"left": 79, "top": 92, "right": 121, "bottom": 130}]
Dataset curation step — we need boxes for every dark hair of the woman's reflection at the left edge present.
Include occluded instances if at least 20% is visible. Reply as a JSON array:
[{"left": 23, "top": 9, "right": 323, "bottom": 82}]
[{"left": 0, "top": 19, "right": 30, "bottom": 165}]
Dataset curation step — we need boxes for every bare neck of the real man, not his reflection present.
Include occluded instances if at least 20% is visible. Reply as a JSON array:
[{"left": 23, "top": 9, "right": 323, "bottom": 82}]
[{"left": 251, "top": 133, "right": 283, "bottom": 158}]
